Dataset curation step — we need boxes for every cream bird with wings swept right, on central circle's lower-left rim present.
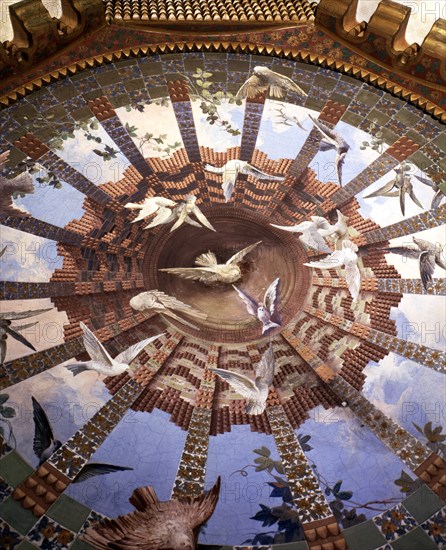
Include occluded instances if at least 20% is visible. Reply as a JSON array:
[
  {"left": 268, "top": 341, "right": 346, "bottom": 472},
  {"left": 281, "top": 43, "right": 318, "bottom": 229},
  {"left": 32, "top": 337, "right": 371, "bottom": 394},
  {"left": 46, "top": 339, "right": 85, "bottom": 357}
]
[{"left": 130, "top": 289, "right": 207, "bottom": 330}]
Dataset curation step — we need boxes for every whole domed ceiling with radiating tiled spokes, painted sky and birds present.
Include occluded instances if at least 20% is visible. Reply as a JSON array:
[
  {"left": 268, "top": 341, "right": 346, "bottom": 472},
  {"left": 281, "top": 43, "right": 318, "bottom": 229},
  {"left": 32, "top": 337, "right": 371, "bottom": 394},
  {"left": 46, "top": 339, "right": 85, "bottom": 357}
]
[{"left": 0, "top": 1, "right": 446, "bottom": 549}]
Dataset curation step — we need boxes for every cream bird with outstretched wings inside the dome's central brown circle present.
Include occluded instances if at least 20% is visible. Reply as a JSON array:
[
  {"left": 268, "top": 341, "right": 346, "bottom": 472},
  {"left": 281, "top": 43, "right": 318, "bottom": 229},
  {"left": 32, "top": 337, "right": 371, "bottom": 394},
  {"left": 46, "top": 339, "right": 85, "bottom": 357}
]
[{"left": 160, "top": 241, "right": 262, "bottom": 284}]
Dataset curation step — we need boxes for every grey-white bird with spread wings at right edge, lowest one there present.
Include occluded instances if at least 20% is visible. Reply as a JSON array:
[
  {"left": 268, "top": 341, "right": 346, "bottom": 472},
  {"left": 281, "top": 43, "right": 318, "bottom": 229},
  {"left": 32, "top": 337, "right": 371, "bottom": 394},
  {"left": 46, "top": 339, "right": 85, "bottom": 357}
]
[{"left": 383, "top": 237, "right": 446, "bottom": 290}]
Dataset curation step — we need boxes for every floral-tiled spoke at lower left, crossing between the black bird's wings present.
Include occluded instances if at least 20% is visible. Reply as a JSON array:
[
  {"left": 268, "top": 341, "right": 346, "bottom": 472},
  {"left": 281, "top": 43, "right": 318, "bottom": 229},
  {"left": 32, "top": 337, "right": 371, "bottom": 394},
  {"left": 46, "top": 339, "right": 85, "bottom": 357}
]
[{"left": 13, "top": 333, "right": 182, "bottom": 517}]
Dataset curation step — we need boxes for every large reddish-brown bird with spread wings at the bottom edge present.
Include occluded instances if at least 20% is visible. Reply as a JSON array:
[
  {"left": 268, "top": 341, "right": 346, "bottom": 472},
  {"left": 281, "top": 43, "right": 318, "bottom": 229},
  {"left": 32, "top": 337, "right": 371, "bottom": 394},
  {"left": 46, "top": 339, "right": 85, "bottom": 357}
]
[{"left": 84, "top": 477, "right": 220, "bottom": 550}]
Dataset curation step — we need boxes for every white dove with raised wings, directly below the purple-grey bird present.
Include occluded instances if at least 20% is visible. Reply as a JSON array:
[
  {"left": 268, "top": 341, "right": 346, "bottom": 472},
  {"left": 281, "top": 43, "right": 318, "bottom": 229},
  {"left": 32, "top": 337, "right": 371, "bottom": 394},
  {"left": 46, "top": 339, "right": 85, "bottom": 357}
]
[{"left": 210, "top": 344, "right": 274, "bottom": 414}]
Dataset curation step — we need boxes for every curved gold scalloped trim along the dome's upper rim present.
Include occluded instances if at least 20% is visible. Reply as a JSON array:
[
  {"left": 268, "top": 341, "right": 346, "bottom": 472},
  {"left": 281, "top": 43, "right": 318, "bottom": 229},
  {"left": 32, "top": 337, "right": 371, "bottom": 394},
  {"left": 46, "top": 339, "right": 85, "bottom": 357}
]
[{"left": 0, "top": 40, "right": 446, "bottom": 122}]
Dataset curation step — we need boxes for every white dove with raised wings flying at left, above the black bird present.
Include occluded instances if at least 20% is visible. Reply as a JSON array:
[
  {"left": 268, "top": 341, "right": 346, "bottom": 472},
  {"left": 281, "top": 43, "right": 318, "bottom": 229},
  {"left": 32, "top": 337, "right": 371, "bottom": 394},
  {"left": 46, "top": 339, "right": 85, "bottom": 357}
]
[{"left": 66, "top": 322, "right": 163, "bottom": 376}]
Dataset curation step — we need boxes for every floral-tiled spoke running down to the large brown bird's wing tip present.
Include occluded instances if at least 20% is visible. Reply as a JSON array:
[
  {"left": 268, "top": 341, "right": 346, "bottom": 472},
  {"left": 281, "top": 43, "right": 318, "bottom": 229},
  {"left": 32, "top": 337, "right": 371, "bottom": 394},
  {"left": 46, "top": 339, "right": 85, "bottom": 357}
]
[{"left": 172, "top": 345, "right": 219, "bottom": 498}]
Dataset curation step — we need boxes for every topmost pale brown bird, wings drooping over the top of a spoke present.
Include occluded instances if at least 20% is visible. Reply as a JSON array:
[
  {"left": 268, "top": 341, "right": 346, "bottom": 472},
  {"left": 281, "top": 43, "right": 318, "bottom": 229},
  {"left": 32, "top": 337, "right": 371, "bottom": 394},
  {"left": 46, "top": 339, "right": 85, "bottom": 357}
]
[{"left": 235, "top": 67, "right": 308, "bottom": 100}]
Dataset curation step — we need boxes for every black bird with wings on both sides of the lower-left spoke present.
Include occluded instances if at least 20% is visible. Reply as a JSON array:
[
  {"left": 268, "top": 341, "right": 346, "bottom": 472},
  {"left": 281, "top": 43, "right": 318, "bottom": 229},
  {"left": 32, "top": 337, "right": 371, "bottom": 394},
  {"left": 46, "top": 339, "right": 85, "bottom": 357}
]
[{"left": 31, "top": 396, "right": 133, "bottom": 483}]
